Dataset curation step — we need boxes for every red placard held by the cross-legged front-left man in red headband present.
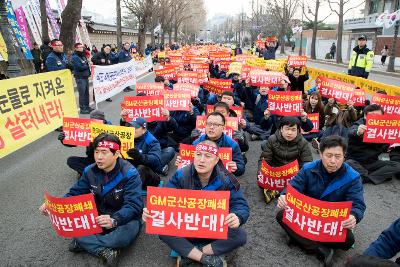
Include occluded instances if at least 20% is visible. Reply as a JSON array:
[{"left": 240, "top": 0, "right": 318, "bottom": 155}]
[{"left": 44, "top": 192, "right": 103, "bottom": 237}]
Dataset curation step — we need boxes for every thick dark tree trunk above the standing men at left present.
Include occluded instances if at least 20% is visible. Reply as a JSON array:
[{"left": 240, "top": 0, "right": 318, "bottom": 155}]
[{"left": 60, "top": 0, "right": 83, "bottom": 55}]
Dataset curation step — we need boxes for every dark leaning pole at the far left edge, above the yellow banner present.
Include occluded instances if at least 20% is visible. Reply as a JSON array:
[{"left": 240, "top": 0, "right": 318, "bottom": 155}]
[{"left": 0, "top": 0, "right": 21, "bottom": 78}]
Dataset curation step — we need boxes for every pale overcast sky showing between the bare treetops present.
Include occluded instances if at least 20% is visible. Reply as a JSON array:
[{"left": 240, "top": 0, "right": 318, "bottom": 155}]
[{"left": 12, "top": 0, "right": 364, "bottom": 23}]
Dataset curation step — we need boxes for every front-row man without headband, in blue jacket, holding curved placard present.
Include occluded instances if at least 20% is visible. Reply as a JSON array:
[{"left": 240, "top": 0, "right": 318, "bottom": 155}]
[{"left": 276, "top": 135, "right": 366, "bottom": 266}]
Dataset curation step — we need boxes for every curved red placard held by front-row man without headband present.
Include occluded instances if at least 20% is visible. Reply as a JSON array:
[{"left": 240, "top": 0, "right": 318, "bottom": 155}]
[{"left": 283, "top": 184, "right": 352, "bottom": 242}]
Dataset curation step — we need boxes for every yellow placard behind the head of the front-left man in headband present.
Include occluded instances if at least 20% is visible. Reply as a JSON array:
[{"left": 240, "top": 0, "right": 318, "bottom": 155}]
[{"left": 90, "top": 122, "right": 135, "bottom": 159}]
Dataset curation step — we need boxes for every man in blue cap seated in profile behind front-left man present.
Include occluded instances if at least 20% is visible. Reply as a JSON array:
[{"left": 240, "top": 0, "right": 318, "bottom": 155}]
[{"left": 125, "top": 117, "right": 163, "bottom": 190}]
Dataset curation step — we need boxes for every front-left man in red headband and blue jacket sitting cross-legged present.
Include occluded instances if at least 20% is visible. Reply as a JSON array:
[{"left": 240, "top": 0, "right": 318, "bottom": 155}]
[{"left": 39, "top": 133, "right": 143, "bottom": 265}]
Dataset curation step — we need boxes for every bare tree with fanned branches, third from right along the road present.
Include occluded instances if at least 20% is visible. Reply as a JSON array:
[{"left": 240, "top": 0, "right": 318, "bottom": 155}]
[{"left": 271, "top": 0, "right": 299, "bottom": 54}]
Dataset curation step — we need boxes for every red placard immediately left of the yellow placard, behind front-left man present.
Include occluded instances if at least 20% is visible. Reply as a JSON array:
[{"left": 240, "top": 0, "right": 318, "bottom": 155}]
[{"left": 62, "top": 117, "right": 103, "bottom": 146}]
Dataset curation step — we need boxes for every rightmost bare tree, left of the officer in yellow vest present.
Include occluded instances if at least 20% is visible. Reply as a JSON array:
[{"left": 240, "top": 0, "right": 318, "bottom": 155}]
[{"left": 328, "top": 0, "right": 365, "bottom": 63}]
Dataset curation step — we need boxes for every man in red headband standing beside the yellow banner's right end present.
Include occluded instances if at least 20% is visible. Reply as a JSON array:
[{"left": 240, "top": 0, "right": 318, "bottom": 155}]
[{"left": 71, "top": 43, "right": 93, "bottom": 114}]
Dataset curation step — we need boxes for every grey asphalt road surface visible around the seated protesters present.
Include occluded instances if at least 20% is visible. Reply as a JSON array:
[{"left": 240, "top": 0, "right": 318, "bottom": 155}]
[{"left": 0, "top": 64, "right": 400, "bottom": 267}]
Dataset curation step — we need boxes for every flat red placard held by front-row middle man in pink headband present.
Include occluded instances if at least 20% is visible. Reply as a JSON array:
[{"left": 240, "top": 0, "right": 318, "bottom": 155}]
[{"left": 146, "top": 187, "right": 230, "bottom": 239}]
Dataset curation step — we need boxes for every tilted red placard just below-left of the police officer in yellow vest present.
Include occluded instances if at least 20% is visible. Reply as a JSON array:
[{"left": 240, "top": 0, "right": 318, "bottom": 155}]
[{"left": 316, "top": 76, "right": 356, "bottom": 103}]
